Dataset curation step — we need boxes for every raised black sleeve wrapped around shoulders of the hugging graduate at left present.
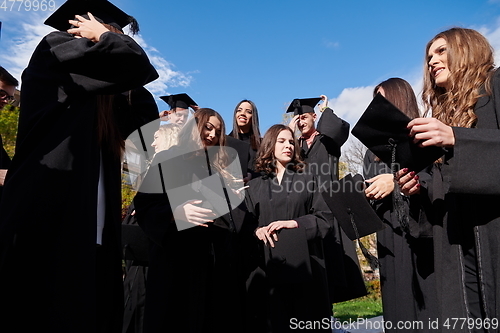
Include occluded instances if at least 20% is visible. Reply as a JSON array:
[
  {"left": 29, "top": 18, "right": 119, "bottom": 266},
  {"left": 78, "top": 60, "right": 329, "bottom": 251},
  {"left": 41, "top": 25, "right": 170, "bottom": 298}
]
[{"left": 42, "top": 31, "right": 158, "bottom": 94}]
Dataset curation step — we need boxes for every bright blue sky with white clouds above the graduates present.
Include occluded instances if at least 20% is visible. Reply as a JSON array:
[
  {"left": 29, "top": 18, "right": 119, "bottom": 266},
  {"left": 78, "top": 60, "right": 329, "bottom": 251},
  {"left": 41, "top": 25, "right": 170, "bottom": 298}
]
[{"left": 0, "top": 0, "right": 500, "bottom": 150}]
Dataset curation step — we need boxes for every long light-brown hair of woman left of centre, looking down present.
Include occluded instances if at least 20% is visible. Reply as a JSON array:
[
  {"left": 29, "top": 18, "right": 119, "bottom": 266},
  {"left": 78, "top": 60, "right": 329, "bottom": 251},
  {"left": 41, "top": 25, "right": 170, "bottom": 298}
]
[{"left": 177, "top": 108, "right": 228, "bottom": 172}]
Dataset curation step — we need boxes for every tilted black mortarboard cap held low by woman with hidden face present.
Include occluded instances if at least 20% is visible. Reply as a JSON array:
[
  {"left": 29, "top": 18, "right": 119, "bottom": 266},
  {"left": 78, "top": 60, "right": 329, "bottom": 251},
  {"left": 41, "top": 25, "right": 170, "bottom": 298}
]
[{"left": 322, "top": 174, "right": 385, "bottom": 240}]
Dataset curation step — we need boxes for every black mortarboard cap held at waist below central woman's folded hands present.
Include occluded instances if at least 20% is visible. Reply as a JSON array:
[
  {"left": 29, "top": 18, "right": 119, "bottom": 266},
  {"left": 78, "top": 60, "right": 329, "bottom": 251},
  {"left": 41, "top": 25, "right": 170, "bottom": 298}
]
[{"left": 264, "top": 228, "right": 312, "bottom": 284}]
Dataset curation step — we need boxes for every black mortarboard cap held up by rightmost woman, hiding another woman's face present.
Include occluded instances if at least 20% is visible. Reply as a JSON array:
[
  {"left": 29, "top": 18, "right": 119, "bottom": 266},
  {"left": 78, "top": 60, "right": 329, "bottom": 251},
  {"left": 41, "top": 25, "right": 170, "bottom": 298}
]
[{"left": 351, "top": 94, "right": 446, "bottom": 172}]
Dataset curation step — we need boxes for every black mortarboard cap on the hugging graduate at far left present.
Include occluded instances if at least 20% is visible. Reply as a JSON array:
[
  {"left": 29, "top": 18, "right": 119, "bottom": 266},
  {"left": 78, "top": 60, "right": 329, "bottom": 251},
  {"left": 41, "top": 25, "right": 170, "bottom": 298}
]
[{"left": 44, "top": 0, "right": 139, "bottom": 34}]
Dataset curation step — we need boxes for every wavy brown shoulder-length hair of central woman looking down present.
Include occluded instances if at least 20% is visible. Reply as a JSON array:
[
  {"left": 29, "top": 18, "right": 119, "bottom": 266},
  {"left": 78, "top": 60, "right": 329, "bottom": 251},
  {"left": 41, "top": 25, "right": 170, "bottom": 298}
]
[{"left": 255, "top": 124, "right": 305, "bottom": 175}]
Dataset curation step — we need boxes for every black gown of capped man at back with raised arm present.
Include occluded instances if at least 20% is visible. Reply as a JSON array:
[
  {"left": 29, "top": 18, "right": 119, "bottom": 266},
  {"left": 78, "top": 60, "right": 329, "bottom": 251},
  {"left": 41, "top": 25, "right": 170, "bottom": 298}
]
[{"left": 301, "top": 108, "right": 367, "bottom": 303}]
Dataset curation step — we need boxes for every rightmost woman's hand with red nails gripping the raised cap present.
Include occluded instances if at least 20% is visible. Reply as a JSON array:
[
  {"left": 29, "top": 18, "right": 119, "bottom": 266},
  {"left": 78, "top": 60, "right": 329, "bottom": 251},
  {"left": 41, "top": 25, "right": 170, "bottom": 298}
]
[{"left": 407, "top": 118, "right": 455, "bottom": 147}]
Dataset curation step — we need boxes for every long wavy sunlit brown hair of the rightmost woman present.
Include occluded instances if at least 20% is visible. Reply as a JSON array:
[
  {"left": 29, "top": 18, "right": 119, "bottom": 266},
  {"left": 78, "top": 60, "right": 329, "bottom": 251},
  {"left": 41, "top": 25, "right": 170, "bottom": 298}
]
[{"left": 422, "top": 28, "right": 494, "bottom": 127}]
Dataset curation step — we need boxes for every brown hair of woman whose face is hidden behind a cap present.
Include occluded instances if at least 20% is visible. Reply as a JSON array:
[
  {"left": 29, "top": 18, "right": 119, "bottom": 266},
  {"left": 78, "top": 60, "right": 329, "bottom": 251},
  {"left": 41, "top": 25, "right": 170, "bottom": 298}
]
[{"left": 373, "top": 77, "right": 420, "bottom": 119}]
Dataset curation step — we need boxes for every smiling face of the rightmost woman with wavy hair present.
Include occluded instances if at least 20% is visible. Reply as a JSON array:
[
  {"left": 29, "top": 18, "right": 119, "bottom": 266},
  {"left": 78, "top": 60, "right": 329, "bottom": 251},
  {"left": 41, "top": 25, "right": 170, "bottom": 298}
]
[{"left": 427, "top": 38, "right": 450, "bottom": 89}]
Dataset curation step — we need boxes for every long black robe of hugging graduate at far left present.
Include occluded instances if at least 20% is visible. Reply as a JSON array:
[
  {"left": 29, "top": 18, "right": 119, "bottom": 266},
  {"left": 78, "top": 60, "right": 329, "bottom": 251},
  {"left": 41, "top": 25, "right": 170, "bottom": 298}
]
[{"left": 0, "top": 31, "right": 158, "bottom": 333}]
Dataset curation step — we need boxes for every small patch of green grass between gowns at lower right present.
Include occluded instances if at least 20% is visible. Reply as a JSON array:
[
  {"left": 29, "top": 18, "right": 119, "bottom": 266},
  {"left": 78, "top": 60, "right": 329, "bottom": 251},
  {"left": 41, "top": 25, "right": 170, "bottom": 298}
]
[{"left": 333, "top": 280, "right": 382, "bottom": 322}]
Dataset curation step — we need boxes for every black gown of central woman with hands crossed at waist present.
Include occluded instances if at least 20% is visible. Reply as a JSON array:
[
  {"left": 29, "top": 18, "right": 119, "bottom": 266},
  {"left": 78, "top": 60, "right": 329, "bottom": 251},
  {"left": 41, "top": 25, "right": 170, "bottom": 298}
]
[{"left": 245, "top": 170, "right": 333, "bottom": 332}]
